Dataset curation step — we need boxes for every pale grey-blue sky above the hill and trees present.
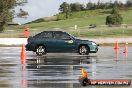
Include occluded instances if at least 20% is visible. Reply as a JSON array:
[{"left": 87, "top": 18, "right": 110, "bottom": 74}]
[{"left": 13, "top": 0, "right": 126, "bottom": 24}]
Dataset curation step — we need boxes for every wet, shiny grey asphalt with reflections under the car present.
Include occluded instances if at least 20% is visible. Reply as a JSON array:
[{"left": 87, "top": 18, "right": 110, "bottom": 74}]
[{"left": 0, "top": 47, "right": 132, "bottom": 88}]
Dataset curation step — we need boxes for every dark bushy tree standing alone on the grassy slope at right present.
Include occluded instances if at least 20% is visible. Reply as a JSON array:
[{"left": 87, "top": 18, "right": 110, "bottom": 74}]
[{"left": 106, "top": 4, "right": 123, "bottom": 25}]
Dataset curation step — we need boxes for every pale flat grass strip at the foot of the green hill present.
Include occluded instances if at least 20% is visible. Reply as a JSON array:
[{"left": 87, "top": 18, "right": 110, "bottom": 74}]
[{"left": 0, "top": 26, "right": 132, "bottom": 38}]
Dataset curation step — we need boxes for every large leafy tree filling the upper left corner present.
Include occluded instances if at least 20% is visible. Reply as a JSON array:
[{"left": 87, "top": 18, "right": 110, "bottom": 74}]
[{"left": 0, "top": 0, "right": 25, "bottom": 32}]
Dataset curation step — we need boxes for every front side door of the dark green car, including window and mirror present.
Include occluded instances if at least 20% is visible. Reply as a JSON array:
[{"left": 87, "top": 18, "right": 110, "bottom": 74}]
[{"left": 54, "top": 31, "right": 77, "bottom": 52}]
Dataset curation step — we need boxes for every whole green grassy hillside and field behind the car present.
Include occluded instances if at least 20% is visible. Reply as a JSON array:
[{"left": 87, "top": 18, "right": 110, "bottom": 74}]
[{"left": 0, "top": 10, "right": 132, "bottom": 37}]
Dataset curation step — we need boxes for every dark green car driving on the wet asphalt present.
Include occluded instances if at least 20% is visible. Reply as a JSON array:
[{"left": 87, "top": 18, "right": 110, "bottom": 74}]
[{"left": 26, "top": 31, "right": 98, "bottom": 56}]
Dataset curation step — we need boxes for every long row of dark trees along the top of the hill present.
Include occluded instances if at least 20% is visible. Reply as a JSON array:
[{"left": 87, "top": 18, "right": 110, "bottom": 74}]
[{"left": 59, "top": 0, "right": 132, "bottom": 13}]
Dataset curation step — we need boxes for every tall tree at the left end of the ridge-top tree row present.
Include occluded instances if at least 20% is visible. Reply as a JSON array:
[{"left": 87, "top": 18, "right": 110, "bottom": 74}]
[{"left": 59, "top": 2, "right": 71, "bottom": 19}]
